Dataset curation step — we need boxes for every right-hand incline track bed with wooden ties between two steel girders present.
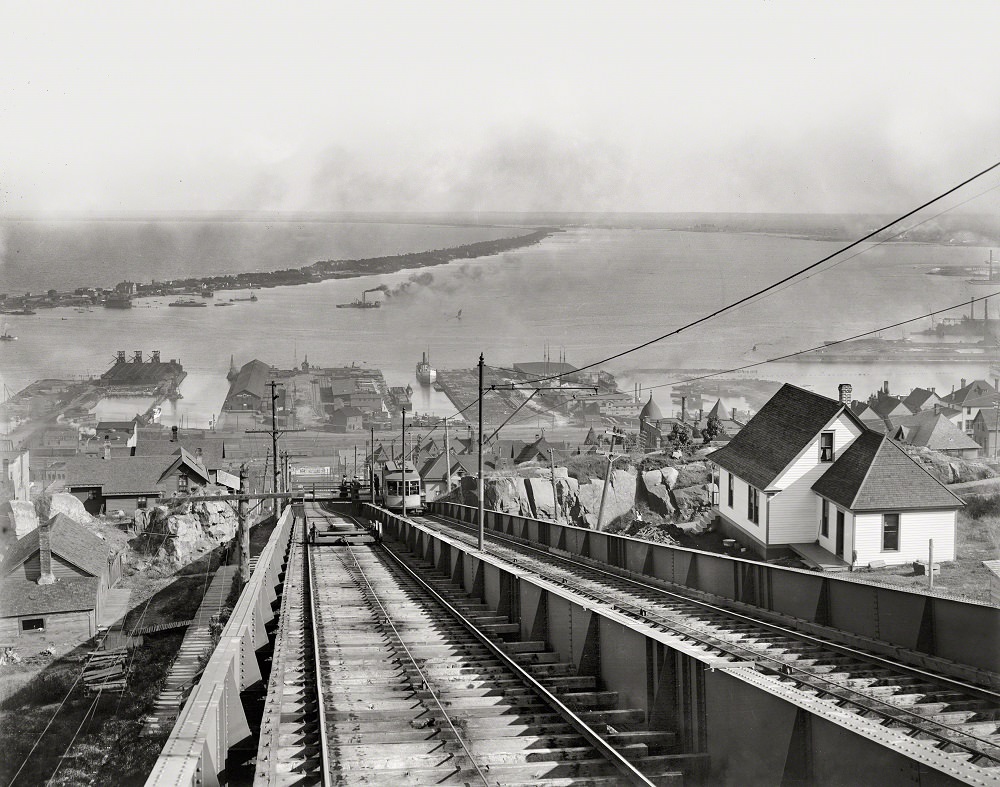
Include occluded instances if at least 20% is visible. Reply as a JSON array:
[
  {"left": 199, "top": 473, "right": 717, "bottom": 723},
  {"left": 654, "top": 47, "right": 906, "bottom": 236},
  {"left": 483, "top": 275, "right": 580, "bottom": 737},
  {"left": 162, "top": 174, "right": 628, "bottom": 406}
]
[{"left": 410, "top": 508, "right": 1000, "bottom": 784}]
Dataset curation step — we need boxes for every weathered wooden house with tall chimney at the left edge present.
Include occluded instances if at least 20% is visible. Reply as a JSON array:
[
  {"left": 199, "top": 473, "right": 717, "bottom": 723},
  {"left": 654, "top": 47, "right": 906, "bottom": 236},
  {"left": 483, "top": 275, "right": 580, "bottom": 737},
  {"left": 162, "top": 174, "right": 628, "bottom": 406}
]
[{"left": 0, "top": 514, "right": 122, "bottom": 642}]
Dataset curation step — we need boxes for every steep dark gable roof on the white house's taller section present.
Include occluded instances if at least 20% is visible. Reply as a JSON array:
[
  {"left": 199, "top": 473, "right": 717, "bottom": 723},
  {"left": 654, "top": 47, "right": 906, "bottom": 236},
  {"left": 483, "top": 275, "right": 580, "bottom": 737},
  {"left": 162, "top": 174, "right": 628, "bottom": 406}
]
[{"left": 708, "top": 383, "right": 863, "bottom": 489}]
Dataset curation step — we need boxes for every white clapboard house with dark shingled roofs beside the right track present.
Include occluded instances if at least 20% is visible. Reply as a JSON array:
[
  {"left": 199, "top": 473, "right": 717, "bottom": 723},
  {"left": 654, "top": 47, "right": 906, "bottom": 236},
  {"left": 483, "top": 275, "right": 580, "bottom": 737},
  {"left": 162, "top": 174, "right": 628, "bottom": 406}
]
[{"left": 708, "top": 385, "right": 961, "bottom": 569}]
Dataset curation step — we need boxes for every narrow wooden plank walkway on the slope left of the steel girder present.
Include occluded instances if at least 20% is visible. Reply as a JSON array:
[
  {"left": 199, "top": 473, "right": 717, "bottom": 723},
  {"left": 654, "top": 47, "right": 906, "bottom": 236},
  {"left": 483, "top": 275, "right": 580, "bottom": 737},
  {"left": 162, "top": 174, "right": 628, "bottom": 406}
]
[{"left": 142, "top": 566, "right": 239, "bottom": 736}]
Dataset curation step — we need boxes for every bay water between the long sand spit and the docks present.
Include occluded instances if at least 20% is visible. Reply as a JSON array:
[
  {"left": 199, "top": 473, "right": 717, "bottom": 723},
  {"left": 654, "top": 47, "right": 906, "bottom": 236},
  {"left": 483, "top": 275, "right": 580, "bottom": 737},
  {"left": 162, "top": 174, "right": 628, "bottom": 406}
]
[{"left": 0, "top": 222, "right": 996, "bottom": 426}]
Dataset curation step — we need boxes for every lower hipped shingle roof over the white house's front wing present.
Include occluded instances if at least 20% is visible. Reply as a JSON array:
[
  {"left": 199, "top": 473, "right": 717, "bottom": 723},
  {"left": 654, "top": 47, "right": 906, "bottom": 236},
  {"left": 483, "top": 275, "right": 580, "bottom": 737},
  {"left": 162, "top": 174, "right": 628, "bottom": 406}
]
[{"left": 812, "top": 431, "right": 965, "bottom": 513}]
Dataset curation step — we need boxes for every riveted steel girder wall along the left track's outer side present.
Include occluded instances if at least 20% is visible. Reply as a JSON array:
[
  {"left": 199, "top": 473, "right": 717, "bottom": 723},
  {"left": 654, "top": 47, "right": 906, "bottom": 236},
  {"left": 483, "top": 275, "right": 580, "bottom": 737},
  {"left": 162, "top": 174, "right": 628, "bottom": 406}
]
[{"left": 146, "top": 506, "right": 294, "bottom": 787}]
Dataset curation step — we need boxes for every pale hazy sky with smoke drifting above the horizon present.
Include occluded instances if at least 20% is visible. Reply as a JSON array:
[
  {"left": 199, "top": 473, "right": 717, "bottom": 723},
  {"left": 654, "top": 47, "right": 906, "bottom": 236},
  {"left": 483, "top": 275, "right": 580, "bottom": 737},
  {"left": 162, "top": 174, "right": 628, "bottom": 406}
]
[{"left": 0, "top": 0, "right": 1000, "bottom": 214}]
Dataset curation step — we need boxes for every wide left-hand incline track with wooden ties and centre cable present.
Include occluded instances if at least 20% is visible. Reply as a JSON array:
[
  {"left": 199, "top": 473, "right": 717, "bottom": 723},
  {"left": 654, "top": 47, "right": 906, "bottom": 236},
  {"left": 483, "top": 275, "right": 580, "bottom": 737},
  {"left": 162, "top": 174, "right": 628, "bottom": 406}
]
[{"left": 256, "top": 506, "right": 698, "bottom": 787}]
